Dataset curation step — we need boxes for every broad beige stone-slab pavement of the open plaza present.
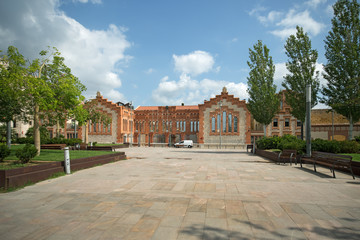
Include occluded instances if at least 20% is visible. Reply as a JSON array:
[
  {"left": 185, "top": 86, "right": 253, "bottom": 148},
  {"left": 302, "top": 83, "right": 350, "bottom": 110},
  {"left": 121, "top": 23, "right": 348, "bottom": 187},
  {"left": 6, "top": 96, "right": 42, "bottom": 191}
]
[{"left": 0, "top": 147, "right": 360, "bottom": 240}]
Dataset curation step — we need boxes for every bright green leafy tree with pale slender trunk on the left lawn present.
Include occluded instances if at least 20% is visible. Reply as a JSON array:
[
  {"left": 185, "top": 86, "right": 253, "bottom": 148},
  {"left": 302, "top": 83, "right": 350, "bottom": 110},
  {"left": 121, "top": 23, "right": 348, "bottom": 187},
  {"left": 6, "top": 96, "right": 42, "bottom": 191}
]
[{"left": 25, "top": 48, "right": 85, "bottom": 154}]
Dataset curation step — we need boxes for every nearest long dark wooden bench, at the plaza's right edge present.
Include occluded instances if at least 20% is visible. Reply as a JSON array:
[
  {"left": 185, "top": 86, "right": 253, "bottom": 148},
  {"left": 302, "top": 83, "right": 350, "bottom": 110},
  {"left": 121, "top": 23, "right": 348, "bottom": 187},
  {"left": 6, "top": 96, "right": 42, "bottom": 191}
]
[{"left": 300, "top": 152, "right": 355, "bottom": 179}]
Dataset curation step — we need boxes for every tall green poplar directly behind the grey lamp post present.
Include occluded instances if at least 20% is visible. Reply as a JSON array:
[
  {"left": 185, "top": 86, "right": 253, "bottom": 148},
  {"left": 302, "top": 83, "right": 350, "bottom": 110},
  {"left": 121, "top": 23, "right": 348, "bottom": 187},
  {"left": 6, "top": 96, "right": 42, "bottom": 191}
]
[{"left": 282, "top": 26, "right": 320, "bottom": 139}]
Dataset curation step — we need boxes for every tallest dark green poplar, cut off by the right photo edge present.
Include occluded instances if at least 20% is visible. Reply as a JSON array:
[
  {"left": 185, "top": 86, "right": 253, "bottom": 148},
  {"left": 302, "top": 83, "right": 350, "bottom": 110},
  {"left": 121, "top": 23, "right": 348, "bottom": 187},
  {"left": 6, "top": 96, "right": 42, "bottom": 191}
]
[{"left": 321, "top": 0, "right": 360, "bottom": 140}]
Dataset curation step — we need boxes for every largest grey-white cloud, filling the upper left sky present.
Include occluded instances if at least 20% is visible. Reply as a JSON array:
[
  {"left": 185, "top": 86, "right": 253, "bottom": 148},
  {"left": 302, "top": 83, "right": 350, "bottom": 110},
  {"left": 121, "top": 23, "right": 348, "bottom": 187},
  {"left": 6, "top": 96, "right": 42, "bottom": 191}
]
[{"left": 0, "top": 0, "right": 131, "bottom": 101}]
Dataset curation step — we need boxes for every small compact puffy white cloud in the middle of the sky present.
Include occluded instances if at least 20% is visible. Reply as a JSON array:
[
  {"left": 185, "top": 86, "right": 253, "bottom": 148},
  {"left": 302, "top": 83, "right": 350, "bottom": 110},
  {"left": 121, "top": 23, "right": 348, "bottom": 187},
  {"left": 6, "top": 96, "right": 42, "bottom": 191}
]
[{"left": 173, "top": 51, "right": 215, "bottom": 76}]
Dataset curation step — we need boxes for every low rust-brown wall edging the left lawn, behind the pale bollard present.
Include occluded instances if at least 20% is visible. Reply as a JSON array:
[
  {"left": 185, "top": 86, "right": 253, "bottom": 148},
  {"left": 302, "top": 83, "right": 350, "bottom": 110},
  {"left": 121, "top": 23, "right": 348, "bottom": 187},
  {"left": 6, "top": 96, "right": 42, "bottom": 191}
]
[{"left": 0, "top": 152, "right": 126, "bottom": 188}]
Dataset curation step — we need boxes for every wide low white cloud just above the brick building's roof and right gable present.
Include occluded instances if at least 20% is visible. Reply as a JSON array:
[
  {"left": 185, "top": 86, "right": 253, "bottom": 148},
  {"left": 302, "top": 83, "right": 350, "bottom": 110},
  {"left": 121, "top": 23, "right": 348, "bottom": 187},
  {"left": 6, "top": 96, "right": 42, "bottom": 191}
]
[{"left": 152, "top": 73, "right": 248, "bottom": 105}]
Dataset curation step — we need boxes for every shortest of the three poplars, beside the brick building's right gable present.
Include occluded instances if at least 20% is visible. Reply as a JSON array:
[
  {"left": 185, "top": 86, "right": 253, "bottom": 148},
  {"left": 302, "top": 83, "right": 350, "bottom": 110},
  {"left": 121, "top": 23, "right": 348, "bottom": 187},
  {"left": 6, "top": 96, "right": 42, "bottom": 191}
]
[{"left": 247, "top": 40, "right": 280, "bottom": 136}]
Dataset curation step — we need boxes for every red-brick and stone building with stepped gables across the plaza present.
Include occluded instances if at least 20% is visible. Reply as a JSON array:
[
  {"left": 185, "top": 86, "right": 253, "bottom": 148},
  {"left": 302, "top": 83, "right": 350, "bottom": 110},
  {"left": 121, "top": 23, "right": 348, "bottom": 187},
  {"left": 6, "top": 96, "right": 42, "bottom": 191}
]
[{"left": 7, "top": 88, "right": 360, "bottom": 145}]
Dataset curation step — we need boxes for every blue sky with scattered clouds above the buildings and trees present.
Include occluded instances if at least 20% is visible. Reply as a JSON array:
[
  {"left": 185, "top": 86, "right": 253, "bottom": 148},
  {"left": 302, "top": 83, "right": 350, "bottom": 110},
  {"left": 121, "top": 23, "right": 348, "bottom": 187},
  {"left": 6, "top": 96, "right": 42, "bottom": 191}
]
[{"left": 0, "top": 0, "right": 335, "bottom": 108}]
